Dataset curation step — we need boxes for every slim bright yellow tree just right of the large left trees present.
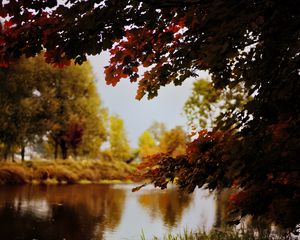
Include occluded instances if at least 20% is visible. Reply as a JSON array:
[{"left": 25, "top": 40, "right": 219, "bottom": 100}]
[{"left": 109, "top": 115, "right": 131, "bottom": 161}]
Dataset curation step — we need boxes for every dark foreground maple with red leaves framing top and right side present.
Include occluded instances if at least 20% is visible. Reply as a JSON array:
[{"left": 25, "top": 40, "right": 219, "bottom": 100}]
[{"left": 0, "top": 0, "right": 300, "bottom": 231}]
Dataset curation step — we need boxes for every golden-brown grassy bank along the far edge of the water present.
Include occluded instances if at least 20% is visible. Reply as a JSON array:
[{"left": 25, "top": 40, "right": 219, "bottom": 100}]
[{"left": 0, "top": 160, "right": 133, "bottom": 184}]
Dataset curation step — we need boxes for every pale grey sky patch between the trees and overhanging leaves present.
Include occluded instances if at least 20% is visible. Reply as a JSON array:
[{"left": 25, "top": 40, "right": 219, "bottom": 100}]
[{"left": 89, "top": 52, "right": 207, "bottom": 147}]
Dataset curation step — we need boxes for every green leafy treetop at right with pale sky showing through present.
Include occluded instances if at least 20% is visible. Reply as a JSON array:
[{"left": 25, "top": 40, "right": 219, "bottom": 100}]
[{"left": 184, "top": 79, "right": 252, "bottom": 129}]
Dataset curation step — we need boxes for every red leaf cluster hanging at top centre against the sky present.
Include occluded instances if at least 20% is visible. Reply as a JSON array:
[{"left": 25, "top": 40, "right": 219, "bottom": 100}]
[{"left": 105, "top": 18, "right": 184, "bottom": 95}]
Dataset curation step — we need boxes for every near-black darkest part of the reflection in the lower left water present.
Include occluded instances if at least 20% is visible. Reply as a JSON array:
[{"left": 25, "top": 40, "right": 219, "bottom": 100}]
[{"left": 0, "top": 204, "right": 101, "bottom": 240}]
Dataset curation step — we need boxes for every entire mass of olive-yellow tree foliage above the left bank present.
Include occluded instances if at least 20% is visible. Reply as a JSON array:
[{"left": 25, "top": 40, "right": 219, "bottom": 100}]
[{"left": 0, "top": 56, "right": 107, "bottom": 158}]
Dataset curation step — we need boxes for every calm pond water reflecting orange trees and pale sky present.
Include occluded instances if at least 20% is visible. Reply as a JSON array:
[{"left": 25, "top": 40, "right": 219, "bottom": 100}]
[{"left": 0, "top": 184, "right": 216, "bottom": 240}]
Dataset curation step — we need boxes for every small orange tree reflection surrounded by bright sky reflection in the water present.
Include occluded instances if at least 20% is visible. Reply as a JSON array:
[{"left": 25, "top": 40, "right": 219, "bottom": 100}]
[{"left": 139, "top": 189, "right": 192, "bottom": 227}]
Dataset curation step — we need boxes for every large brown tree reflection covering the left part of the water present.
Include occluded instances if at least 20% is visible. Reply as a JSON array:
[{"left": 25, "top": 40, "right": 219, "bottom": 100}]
[{"left": 0, "top": 185, "right": 126, "bottom": 240}]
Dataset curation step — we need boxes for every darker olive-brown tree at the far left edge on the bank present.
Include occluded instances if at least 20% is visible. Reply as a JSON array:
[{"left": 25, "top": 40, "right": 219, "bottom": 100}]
[{"left": 0, "top": 58, "right": 51, "bottom": 160}]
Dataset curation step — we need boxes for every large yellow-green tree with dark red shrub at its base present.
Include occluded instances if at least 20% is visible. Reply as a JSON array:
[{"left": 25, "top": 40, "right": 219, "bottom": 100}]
[{"left": 44, "top": 59, "right": 107, "bottom": 159}]
